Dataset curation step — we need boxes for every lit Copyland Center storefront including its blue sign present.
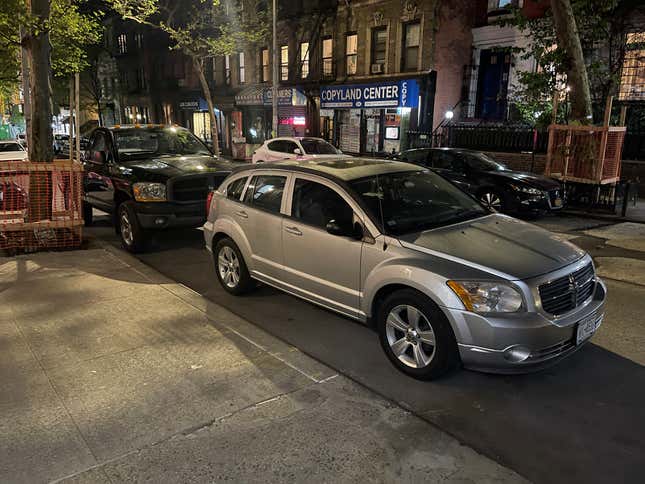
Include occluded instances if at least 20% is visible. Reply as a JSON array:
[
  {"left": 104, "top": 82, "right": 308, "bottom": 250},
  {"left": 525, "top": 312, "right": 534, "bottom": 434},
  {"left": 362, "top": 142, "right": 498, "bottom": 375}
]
[{"left": 320, "top": 78, "right": 426, "bottom": 154}]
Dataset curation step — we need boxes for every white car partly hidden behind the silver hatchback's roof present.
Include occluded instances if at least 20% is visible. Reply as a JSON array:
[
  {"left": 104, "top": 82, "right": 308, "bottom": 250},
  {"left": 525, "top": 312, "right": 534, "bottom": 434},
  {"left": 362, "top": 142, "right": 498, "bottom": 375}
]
[{"left": 251, "top": 137, "right": 351, "bottom": 163}]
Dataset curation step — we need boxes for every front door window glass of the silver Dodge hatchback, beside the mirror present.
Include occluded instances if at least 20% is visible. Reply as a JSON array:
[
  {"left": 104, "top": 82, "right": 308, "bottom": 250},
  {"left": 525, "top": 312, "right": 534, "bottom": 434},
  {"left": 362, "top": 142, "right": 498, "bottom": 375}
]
[{"left": 291, "top": 178, "right": 354, "bottom": 229}]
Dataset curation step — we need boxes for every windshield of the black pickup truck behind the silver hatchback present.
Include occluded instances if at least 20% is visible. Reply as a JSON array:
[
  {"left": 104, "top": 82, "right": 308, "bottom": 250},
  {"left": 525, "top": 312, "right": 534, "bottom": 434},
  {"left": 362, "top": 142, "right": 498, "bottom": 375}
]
[{"left": 114, "top": 128, "right": 211, "bottom": 159}]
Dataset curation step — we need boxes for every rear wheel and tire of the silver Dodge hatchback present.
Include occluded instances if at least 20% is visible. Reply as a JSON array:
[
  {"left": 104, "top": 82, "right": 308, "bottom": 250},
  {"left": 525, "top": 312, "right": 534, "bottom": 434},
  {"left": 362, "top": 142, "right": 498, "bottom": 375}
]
[{"left": 213, "top": 237, "right": 255, "bottom": 296}]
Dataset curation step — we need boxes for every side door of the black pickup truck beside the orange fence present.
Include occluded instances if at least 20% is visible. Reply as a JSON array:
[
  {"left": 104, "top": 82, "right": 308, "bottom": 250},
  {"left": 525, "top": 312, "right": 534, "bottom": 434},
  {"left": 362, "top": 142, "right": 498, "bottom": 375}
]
[{"left": 83, "top": 130, "right": 114, "bottom": 212}]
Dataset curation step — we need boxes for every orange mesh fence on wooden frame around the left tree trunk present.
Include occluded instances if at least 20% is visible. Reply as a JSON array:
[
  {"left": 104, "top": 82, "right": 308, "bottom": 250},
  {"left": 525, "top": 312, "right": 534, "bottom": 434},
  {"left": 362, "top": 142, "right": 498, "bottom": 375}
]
[{"left": 0, "top": 161, "right": 83, "bottom": 251}]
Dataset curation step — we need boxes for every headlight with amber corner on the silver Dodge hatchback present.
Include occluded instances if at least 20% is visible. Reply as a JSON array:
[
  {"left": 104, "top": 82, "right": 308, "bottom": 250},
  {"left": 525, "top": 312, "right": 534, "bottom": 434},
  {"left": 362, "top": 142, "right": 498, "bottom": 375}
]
[{"left": 448, "top": 281, "right": 522, "bottom": 313}]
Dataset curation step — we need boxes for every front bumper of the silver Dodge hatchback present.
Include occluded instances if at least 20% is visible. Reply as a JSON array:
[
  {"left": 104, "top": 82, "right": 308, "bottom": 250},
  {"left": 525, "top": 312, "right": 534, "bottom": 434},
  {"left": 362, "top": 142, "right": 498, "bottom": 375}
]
[{"left": 444, "top": 279, "right": 607, "bottom": 373}]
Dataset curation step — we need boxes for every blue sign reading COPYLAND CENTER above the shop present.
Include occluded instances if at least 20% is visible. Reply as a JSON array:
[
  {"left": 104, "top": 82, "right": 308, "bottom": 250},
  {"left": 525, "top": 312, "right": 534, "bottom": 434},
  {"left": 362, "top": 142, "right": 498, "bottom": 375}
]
[{"left": 320, "top": 79, "right": 419, "bottom": 109}]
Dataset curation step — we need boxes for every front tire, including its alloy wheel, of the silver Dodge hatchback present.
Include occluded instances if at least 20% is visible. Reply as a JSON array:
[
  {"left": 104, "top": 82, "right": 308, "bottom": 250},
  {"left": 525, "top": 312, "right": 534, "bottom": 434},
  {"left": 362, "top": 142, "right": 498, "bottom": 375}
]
[{"left": 377, "top": 289, "right": 460, "bottom": 380}]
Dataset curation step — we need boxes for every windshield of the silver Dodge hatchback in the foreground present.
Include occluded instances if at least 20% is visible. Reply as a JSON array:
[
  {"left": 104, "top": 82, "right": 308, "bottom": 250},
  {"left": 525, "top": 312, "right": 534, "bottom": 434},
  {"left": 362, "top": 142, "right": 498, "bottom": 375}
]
[{"left": 350, "top": 170, "right": 489, "bottom": 236}]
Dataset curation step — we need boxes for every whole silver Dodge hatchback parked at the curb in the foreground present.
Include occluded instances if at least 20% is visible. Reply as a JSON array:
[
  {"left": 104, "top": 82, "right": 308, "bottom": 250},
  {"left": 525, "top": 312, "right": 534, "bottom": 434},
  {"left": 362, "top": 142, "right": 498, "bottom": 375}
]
[{"left": 204, "top": 158, "right": 606, "bottom": 379}]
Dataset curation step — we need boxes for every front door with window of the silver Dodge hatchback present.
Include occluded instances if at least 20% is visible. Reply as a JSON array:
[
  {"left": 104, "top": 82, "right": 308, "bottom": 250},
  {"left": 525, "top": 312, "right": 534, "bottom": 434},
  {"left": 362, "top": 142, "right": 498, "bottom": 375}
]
[{"left": 282, "top": 175, "right": 363, "bottom": 317}]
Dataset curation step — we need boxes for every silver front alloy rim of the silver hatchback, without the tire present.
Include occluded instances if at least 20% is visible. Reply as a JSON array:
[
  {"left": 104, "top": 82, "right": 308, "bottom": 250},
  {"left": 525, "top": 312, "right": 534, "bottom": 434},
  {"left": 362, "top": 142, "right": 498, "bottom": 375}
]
[{"left": 385, "top": 304, "right": 436, "bottom": 368}]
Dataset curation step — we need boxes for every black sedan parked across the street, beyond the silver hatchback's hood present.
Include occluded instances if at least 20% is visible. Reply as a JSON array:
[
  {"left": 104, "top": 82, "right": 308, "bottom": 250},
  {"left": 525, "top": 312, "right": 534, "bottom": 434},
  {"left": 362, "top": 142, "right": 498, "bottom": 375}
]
[{"left": 398, "top": 148, "right": 563, "bottom": 214}]
